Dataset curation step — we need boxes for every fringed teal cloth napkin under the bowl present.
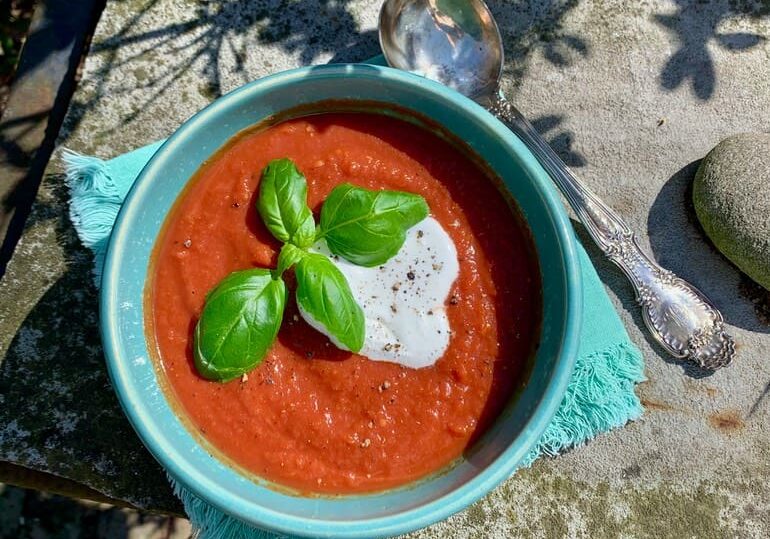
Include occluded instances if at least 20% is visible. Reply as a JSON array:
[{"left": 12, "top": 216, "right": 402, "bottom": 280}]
[{"left": 63, "top": 141, "right": 645, "bottom": 539}]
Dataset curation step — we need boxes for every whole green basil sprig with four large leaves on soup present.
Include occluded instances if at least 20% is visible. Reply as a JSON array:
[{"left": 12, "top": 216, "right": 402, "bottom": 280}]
[{"left": 193, "top": 159, "right": 428, "bottom": 382}]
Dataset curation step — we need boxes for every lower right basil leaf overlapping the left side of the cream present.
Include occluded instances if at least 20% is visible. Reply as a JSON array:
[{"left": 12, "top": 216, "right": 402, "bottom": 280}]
[{"left": 294, "top": 253, "right": 365, "bottom": 352}]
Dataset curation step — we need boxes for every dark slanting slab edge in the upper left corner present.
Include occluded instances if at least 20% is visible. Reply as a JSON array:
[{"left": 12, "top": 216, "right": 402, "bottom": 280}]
[{"left": 0, "top": 0, "right": 106, "bottom": 277}]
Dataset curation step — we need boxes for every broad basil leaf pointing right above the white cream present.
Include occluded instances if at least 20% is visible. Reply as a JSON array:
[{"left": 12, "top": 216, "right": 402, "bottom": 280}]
[{"left": 320, "top": 183, "right": 428, "bottom": 267}]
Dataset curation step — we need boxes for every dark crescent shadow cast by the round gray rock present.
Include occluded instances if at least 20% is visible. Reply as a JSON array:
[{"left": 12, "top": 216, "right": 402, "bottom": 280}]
[{"left": 647, "top": 161, "right": 770, "bottom": 333}]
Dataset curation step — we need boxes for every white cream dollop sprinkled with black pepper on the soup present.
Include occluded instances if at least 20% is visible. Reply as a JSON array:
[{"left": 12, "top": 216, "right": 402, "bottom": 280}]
[{"left": 300, "top": 217, "right": 460, "bottom": 369}]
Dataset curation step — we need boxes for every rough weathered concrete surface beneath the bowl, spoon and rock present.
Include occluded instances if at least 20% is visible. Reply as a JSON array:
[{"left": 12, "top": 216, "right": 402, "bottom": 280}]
[{"left": 0, "top": 0, "right": 770, "bottom": 538}]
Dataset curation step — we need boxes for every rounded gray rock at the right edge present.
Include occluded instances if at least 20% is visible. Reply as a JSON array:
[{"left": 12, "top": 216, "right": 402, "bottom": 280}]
[{"left": 693, "top": 133, "right": 770, "bottom": 290}]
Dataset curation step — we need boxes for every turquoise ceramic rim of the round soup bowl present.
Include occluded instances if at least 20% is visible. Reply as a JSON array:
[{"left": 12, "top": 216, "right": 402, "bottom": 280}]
[{"left": 99, "top": 64, "right": 583, "bottom": 538}]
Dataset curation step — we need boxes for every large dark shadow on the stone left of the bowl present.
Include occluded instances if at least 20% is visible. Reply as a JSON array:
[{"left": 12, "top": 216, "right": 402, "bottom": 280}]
[{"left": 0, "top": 176, "right": 182, "bottom": 514}]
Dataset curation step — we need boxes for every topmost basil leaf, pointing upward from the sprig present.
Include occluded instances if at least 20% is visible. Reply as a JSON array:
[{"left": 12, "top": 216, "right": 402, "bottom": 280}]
[{"left": 257, "top": 159, "right": 315, "bottom": 248}]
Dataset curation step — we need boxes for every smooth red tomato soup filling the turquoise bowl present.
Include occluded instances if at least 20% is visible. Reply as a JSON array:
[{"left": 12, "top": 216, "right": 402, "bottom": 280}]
[{"left": 147, "top": 113, "right": 541, "bottom": 494}]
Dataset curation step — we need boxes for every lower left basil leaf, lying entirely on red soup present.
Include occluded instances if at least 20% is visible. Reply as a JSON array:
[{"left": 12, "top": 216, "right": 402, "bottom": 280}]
[{"left": 193, "top": 268, "right": 286, "bottom": 382}]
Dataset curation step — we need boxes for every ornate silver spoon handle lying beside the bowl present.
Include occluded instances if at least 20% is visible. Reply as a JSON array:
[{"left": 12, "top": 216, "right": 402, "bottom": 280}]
[{"left": 485, "top": 95, "right": 735, "bottom": 370}]
